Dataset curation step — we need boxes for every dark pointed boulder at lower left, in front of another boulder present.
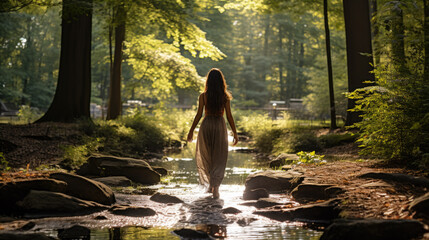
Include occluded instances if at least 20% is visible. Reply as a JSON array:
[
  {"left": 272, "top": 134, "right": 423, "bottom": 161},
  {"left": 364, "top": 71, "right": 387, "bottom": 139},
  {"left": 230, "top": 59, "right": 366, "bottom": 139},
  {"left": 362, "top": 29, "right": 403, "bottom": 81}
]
[{"left": 16, "top": 190, "right": 107, "bottom": 216}]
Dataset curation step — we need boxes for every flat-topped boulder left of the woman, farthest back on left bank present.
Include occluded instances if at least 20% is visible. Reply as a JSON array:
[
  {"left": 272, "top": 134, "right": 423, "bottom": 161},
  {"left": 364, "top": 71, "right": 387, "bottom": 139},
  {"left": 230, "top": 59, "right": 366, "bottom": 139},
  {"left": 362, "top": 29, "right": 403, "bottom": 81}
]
[{"left": 77, "top": 155, "right": 161, "bottom": 184}]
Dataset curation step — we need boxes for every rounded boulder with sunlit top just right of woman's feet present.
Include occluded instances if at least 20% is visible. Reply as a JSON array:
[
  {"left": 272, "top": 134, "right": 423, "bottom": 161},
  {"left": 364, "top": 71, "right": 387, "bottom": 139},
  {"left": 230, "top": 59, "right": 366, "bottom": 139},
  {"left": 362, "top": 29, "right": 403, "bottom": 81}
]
[{"left": 245, "top": 170, "right": 304, "bottom": 193}]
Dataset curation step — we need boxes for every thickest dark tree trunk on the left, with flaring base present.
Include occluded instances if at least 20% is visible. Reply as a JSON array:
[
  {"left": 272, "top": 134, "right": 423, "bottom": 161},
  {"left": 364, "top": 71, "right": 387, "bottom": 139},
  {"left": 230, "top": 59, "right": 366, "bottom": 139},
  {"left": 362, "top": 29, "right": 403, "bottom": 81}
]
[{"left": 37, "top": 0, "right": 92, "bottom": 122}]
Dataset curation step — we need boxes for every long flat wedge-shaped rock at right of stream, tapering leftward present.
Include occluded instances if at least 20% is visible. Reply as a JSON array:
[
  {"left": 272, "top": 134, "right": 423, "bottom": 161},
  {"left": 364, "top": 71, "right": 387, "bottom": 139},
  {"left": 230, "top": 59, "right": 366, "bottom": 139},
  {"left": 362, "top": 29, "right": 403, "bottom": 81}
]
[{"left": 253, "top": 199, "right": 340, "bottom": 224}]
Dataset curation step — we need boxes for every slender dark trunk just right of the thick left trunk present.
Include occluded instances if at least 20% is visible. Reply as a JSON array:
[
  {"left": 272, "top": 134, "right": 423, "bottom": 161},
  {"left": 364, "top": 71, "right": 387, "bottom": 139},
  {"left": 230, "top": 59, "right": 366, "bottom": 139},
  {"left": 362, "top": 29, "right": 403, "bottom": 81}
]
[{"left": 107, "top": 4, "right": 126, "bottom": 120}]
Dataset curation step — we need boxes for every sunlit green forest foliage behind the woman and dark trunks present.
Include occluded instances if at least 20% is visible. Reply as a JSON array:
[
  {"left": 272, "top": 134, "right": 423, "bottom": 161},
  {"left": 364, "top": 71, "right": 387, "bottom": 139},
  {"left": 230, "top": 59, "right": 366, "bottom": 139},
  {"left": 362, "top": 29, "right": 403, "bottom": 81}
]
[{"left": 0, "top": 0, "right": 429, "bottom": 171}]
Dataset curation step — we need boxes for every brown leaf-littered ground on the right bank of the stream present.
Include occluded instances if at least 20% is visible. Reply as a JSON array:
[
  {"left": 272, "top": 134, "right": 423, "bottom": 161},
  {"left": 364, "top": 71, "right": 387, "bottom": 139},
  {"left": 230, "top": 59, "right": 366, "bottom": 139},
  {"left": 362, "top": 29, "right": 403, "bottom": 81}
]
[{"left": 300, "top": 161, "right": 428, "bottom": 219}]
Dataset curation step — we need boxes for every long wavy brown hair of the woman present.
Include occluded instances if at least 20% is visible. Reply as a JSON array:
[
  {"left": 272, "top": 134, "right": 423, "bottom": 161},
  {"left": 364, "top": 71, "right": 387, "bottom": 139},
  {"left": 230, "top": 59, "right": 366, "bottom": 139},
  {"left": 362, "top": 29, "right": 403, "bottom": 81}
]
[{"left": 204, "top": 68, "right": 232, "bottom": 113}]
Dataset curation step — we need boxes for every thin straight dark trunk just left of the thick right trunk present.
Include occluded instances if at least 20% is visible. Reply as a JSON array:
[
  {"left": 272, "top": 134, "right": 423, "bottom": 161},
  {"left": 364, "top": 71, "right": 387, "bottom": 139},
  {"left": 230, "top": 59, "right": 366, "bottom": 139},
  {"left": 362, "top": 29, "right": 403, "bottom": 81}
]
[{"left": 323, "top": 0, "right": 337, "bottom": 129}]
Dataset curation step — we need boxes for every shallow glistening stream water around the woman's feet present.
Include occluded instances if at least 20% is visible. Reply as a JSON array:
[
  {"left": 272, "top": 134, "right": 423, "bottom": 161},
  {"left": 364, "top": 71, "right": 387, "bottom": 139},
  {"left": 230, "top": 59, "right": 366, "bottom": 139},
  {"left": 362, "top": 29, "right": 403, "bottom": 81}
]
[{"left": 8, "top": 140, "right": 322, "bottom": 240}]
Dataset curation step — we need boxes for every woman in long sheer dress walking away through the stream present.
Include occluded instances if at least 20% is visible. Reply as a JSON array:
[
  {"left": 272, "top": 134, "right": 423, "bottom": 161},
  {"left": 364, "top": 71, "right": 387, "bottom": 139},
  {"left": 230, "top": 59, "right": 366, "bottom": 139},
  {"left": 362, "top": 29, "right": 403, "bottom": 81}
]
[{"left": 188, "top": 68, "right": 238, "bottom": 198}]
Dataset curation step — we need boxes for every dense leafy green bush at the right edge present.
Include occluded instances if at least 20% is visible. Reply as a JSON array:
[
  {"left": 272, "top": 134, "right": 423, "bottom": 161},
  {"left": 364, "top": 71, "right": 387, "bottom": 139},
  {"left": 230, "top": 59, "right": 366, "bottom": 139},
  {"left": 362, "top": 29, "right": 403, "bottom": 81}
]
[{"left": 349, "top": 63, "right": 429, "bottom": 167}]
